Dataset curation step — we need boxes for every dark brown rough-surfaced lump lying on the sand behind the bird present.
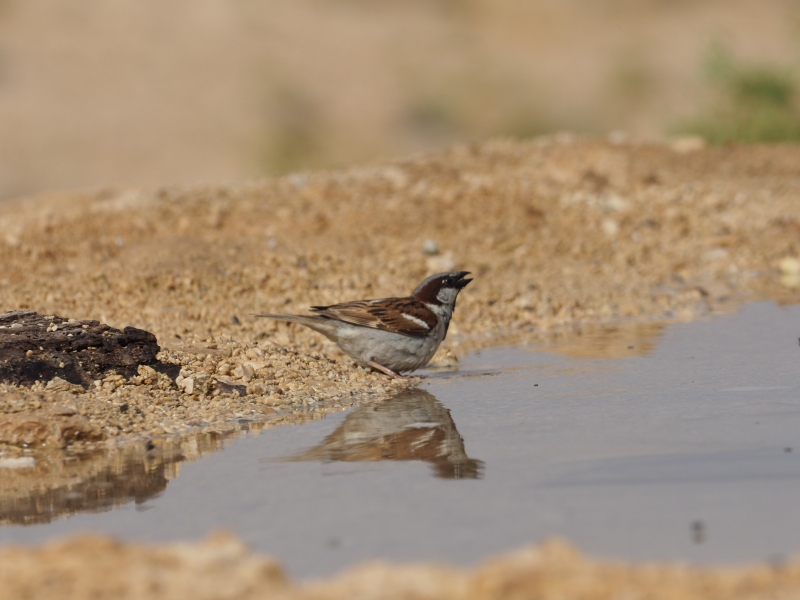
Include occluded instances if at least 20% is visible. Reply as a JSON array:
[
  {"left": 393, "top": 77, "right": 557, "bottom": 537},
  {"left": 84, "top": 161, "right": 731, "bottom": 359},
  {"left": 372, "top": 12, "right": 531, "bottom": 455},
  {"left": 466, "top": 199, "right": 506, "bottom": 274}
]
[{"left": 0, "top": 310, "right": 166, "bottom": 388}]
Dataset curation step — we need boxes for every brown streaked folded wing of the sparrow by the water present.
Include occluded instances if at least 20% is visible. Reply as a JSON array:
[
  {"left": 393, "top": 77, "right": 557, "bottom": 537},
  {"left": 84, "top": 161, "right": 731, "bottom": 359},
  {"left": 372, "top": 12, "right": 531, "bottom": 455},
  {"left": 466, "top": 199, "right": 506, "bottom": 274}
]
[{"left": 311, "top": 298, "right": 437, "bottom": 336}]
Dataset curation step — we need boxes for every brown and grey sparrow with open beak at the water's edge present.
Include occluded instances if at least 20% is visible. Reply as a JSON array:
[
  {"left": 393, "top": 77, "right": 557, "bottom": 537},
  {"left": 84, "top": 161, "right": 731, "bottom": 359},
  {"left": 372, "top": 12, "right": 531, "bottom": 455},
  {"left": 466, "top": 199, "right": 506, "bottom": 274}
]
[{"left": 254, "top": 271, "right": 472, "bottom": 377}]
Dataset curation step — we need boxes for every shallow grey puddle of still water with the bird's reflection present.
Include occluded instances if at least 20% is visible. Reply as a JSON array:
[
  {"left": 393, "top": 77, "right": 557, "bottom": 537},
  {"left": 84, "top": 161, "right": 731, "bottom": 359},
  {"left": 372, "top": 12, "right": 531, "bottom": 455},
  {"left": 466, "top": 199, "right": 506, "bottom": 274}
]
[{"left": 0, "top": 303, "right": 800, "bottom": 577}]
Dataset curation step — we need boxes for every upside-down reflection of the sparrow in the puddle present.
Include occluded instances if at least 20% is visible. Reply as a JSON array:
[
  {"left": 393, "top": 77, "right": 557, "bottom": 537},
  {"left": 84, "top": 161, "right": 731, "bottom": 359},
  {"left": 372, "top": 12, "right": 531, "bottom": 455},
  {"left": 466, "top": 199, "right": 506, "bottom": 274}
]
[{"left": 288, "top": 389, "right": 483, "bottom": 479}]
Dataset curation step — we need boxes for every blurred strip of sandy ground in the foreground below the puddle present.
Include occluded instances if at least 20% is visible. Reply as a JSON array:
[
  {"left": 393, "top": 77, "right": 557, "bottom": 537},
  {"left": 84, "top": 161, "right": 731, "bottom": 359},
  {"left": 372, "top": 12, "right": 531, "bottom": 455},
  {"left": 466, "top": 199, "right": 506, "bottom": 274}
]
[{"left": 0, "top": 534, "right": 800, "bottom": 600}]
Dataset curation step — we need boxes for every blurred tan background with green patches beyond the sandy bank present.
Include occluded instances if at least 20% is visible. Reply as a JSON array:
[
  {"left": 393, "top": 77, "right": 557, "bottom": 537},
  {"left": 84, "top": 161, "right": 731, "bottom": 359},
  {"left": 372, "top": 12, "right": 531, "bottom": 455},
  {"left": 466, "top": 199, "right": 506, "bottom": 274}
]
[{"left": 0, "top": 0, "right": 800, "bottom": 199}]
